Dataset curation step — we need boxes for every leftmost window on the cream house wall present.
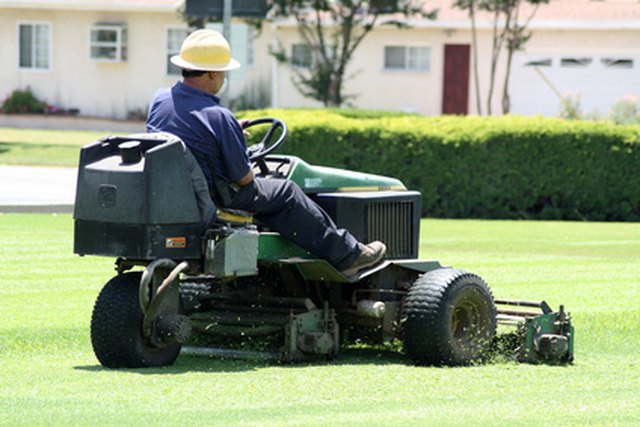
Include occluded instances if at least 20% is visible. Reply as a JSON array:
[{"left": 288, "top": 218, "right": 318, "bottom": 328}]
[{"left": 18, "top": 23, "right": 51, "bottom": 70}]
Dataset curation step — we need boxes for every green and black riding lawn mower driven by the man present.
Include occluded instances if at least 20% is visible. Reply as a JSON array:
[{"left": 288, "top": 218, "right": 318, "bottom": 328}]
[{"left": 74, "top": 118, "right": 574, "bottom": 368}]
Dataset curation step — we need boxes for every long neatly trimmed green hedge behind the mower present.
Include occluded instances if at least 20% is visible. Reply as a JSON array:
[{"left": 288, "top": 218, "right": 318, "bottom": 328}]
[{"left": 241, "top": 109, "right": 640, "bottom": 221}]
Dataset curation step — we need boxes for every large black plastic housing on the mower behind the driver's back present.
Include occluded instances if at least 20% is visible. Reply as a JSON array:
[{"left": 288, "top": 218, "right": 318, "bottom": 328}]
[{"left": 74, "top": 133, "right": 215, "bottom": 259}]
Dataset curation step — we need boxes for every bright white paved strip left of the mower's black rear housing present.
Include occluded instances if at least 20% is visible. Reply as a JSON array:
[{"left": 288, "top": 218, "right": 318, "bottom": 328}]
[{"left": 0, "top": 166, "right": 78, "bottom": 213}]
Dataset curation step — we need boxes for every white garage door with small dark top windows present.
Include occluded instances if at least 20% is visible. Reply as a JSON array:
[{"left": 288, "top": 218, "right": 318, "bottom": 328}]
[{"left": 509, "top": 53, "right": 640, "bottom": 116}]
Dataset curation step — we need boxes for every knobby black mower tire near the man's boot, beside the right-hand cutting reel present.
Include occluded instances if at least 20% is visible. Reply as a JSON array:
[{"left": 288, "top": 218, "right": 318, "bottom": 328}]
[{"left": 402, "top": 268, "right": 496, "bottom": 365}]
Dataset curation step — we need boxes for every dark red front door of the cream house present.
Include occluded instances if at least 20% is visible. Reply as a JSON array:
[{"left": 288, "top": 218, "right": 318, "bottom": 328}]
[{"left": 442, "top": 44, "right": 471, "bottom": 114}]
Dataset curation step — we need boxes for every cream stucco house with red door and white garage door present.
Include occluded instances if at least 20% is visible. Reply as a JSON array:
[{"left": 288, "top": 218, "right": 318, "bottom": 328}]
[{"left": 0, "top": 0, "right": 640, "bottom": 118}]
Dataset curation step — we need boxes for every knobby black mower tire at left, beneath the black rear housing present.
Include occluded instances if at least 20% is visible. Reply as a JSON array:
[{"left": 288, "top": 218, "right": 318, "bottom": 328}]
[{"left": 91, "top": 272, "right": 181, "bottom": 368}]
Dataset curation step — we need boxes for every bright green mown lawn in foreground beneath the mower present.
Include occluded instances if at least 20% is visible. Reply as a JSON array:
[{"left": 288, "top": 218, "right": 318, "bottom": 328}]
[{"left": 0, "top": 214, "right": 640, "bottom": 426}]
